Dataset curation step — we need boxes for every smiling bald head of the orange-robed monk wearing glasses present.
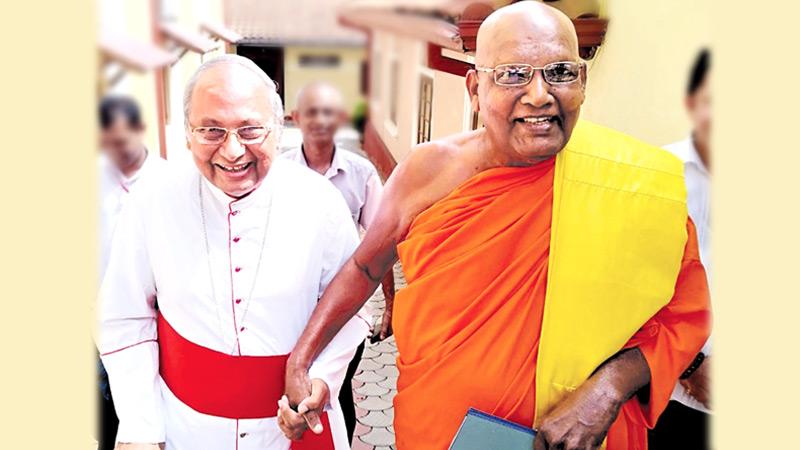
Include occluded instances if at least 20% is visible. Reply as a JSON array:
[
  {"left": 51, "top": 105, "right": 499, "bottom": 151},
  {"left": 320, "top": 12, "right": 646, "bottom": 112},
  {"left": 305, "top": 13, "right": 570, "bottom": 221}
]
[{"left": 467, "top": 2, "right": 586, "bottom": 164}]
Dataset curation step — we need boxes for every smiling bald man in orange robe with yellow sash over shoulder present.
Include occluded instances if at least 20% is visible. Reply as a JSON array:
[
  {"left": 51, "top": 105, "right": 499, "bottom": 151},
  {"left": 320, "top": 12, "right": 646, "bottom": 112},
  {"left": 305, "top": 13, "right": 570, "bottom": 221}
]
[{"left": 279, "top": 1, "right": 710, "bottom": 450}]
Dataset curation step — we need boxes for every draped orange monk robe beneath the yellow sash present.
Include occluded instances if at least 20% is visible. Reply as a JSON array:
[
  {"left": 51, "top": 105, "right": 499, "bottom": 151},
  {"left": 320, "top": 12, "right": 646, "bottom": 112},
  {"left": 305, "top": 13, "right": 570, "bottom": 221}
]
[{"left": 393, "top": 158, "right": 709, "bottom": 450}]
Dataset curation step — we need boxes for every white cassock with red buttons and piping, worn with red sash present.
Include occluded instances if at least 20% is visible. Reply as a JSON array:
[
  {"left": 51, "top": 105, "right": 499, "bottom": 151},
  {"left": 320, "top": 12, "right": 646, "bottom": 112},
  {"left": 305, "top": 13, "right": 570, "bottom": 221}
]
[{"left": 98, "top": 160, "right": 367, "bottom": 450}]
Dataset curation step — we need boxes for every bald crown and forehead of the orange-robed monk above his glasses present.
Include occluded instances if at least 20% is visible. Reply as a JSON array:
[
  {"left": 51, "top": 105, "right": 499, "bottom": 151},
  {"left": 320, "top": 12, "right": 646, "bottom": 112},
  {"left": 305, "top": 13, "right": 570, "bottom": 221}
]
[{"left": 475, "top": 1, "right": 578, "bottom": 66}]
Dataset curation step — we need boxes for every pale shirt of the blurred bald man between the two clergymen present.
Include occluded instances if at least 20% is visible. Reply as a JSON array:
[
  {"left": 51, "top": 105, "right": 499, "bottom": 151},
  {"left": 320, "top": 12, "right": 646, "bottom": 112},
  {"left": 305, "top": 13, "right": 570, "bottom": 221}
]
[{"left": 280, "top": 146, "right": 383, "bottom": 230}]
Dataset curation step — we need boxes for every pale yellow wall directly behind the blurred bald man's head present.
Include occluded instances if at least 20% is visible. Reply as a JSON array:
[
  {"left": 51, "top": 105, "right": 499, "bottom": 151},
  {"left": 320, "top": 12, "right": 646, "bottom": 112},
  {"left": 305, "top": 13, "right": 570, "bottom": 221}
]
[{"left": 283, "top": 46, "right": 367, "bottom": 114}]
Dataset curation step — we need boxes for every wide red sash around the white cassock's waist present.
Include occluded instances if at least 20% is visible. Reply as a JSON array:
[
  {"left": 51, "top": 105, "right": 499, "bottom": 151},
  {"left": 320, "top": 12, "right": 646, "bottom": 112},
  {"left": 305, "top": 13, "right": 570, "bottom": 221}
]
[{"left": 158, "top": 314, "right": 334, "bottom": 450}]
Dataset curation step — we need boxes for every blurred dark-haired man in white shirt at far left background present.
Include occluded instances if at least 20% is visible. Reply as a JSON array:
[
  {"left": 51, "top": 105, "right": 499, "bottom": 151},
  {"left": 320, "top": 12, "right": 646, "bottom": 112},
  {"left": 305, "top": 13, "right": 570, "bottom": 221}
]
[{"left": 97, "top": 96, "right": 166, "bottom": 450}]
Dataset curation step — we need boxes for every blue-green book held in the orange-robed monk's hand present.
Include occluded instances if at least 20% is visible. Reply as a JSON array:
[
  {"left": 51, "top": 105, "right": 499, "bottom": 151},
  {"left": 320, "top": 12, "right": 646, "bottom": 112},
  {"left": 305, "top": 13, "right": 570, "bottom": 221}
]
[{"left": 450, "top": 408, "right": 536, "bottom": 450}]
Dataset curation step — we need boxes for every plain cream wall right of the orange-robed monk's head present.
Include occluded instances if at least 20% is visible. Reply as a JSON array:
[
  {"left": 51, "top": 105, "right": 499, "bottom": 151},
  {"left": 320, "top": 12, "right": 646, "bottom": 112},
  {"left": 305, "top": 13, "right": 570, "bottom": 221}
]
[{"left": 582, "top": 0, "right": 711, "bottom": 145}]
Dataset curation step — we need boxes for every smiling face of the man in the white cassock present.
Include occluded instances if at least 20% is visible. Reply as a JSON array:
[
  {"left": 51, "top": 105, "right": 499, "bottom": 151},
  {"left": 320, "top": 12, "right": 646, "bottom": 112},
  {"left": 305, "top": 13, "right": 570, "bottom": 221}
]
[{"left": 187, "top": 64, "right": 278, "bottom": 198}]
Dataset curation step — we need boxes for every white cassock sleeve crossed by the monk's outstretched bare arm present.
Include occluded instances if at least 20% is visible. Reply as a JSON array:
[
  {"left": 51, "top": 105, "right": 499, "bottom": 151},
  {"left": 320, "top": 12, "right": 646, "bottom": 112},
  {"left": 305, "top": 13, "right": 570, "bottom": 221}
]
[{"left": 308, "top": 192, "right": 369, "bottom": 403}]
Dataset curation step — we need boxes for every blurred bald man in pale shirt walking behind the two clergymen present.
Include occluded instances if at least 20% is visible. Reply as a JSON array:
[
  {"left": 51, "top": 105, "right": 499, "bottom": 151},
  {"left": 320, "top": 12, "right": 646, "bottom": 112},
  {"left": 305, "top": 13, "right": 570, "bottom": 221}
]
[{"left": 281, "top": 81, "right": 394, "bottom": 444}]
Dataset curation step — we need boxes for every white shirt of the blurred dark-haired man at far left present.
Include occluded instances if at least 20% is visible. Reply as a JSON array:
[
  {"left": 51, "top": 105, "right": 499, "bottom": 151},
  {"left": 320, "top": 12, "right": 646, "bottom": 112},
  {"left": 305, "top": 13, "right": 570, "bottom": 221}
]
[{"left": 97, "top": 151, "right": 167, "bottom": 280}]
